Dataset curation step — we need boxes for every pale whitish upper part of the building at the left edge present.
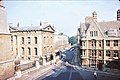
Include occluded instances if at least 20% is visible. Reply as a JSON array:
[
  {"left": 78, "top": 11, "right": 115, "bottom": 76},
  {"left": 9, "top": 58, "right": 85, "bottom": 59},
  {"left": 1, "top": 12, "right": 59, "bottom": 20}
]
[{"left": 0, "top": 0, "right": 9, "bottom": 34}]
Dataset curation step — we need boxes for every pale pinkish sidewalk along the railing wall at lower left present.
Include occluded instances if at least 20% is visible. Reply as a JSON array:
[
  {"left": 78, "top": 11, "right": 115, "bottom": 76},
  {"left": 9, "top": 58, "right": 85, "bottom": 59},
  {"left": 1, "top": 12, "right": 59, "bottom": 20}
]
[{"left": 7, "top": 62, "right": 61, "bottom": 80}]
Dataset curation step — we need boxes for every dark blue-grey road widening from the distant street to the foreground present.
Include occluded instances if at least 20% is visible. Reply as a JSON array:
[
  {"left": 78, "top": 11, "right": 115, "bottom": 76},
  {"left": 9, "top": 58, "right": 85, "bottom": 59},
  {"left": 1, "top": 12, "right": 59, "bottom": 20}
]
[{"left": 36, "top": 48, "right": 120, "bottom": 80}]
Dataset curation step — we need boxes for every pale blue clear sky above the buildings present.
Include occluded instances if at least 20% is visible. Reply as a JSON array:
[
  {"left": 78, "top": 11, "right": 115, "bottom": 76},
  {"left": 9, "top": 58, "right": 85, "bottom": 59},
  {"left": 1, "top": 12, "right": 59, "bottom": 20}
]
[{"left": 4, "top": 0, "right": 120, "bottom": 36}]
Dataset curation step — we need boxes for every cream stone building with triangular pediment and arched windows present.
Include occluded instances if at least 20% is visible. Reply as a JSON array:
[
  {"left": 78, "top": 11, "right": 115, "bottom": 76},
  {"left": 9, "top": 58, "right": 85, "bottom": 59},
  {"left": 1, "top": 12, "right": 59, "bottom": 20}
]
[{"left": 10, "top": 24, "right": 55, "bottom": 61}]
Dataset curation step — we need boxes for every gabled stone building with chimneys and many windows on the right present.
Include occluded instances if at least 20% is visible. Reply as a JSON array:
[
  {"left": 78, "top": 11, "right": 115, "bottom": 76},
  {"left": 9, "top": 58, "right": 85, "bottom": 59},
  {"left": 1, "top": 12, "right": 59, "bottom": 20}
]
[{"left": 78, "top": 10, "right": 120, "bottom": 66}]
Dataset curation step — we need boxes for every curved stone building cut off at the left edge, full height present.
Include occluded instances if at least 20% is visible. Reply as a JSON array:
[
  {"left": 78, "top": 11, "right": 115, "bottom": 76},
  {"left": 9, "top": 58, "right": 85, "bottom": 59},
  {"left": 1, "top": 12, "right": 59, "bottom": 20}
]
[{"left": 0, "top": 0, "right": 15, "bottom": 80}]
